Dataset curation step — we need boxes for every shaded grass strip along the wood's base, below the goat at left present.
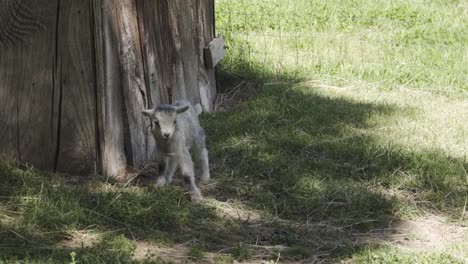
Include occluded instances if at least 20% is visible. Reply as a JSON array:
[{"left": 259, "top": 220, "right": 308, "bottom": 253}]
[{"left": 0, "top": 164, "right": 241, "bottom": 263}]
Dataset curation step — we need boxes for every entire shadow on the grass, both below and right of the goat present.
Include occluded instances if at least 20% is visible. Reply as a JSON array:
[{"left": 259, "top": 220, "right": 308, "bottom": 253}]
[{"left": 0, "top": 60, "right": 466, "bottom": 263}]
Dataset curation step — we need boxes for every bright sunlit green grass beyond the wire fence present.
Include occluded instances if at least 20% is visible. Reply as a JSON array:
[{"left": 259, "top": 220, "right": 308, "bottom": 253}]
[{"left": 216, "top": 0, "right": 468, "bottom": 96}]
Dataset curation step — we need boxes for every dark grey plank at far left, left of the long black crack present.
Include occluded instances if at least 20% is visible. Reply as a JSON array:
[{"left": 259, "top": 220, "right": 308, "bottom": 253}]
[{"left": 17, "top": 0, "right": 57, "bottom": 170}]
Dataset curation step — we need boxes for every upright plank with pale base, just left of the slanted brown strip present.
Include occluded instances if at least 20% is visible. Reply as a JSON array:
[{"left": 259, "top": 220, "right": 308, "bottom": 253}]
[{"left": 92, "top": 0, "right": 127, "bottom": 176}]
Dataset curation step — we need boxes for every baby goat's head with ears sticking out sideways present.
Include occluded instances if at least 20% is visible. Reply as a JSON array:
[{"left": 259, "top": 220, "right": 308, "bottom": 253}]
[{"left": 142, "top": 105, "right": 189, "bottom": 140}]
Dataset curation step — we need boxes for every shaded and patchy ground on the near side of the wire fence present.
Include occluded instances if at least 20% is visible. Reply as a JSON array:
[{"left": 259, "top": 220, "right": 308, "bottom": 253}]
[{"left": 0, "top": 81, "right": 468, "bottom": 263}]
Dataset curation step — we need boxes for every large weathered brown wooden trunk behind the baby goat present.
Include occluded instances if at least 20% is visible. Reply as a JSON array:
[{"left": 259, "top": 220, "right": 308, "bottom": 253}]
[{"left": 0, "top": 0, "right": 216, "bottom": 175}]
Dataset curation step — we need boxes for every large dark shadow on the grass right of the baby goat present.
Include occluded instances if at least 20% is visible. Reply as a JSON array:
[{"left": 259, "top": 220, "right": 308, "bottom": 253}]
[{"left": 204, "top": 62, "right": 467, "bottom": 258}]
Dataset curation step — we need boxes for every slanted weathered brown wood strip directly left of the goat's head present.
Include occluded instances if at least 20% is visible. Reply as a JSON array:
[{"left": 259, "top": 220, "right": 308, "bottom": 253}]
[{"left": 111, "top": 0, "right": 154, "bottom": 168}]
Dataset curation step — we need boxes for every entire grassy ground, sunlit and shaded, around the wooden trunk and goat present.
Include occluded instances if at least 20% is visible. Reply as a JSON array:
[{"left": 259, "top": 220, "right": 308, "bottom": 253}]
[{"left": 0, "top": 0, "right": 468, "bottom": 263}]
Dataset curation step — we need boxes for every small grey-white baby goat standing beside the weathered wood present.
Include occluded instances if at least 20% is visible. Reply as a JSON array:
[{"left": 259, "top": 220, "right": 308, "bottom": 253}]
[{"left": 143, "top": 100, "right": 210, "bottom": 202}]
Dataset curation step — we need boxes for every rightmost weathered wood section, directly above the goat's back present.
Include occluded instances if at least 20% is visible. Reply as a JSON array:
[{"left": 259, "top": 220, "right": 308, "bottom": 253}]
[{"left": 165, "top": 0, "right": 216, "bottom": 111}]
